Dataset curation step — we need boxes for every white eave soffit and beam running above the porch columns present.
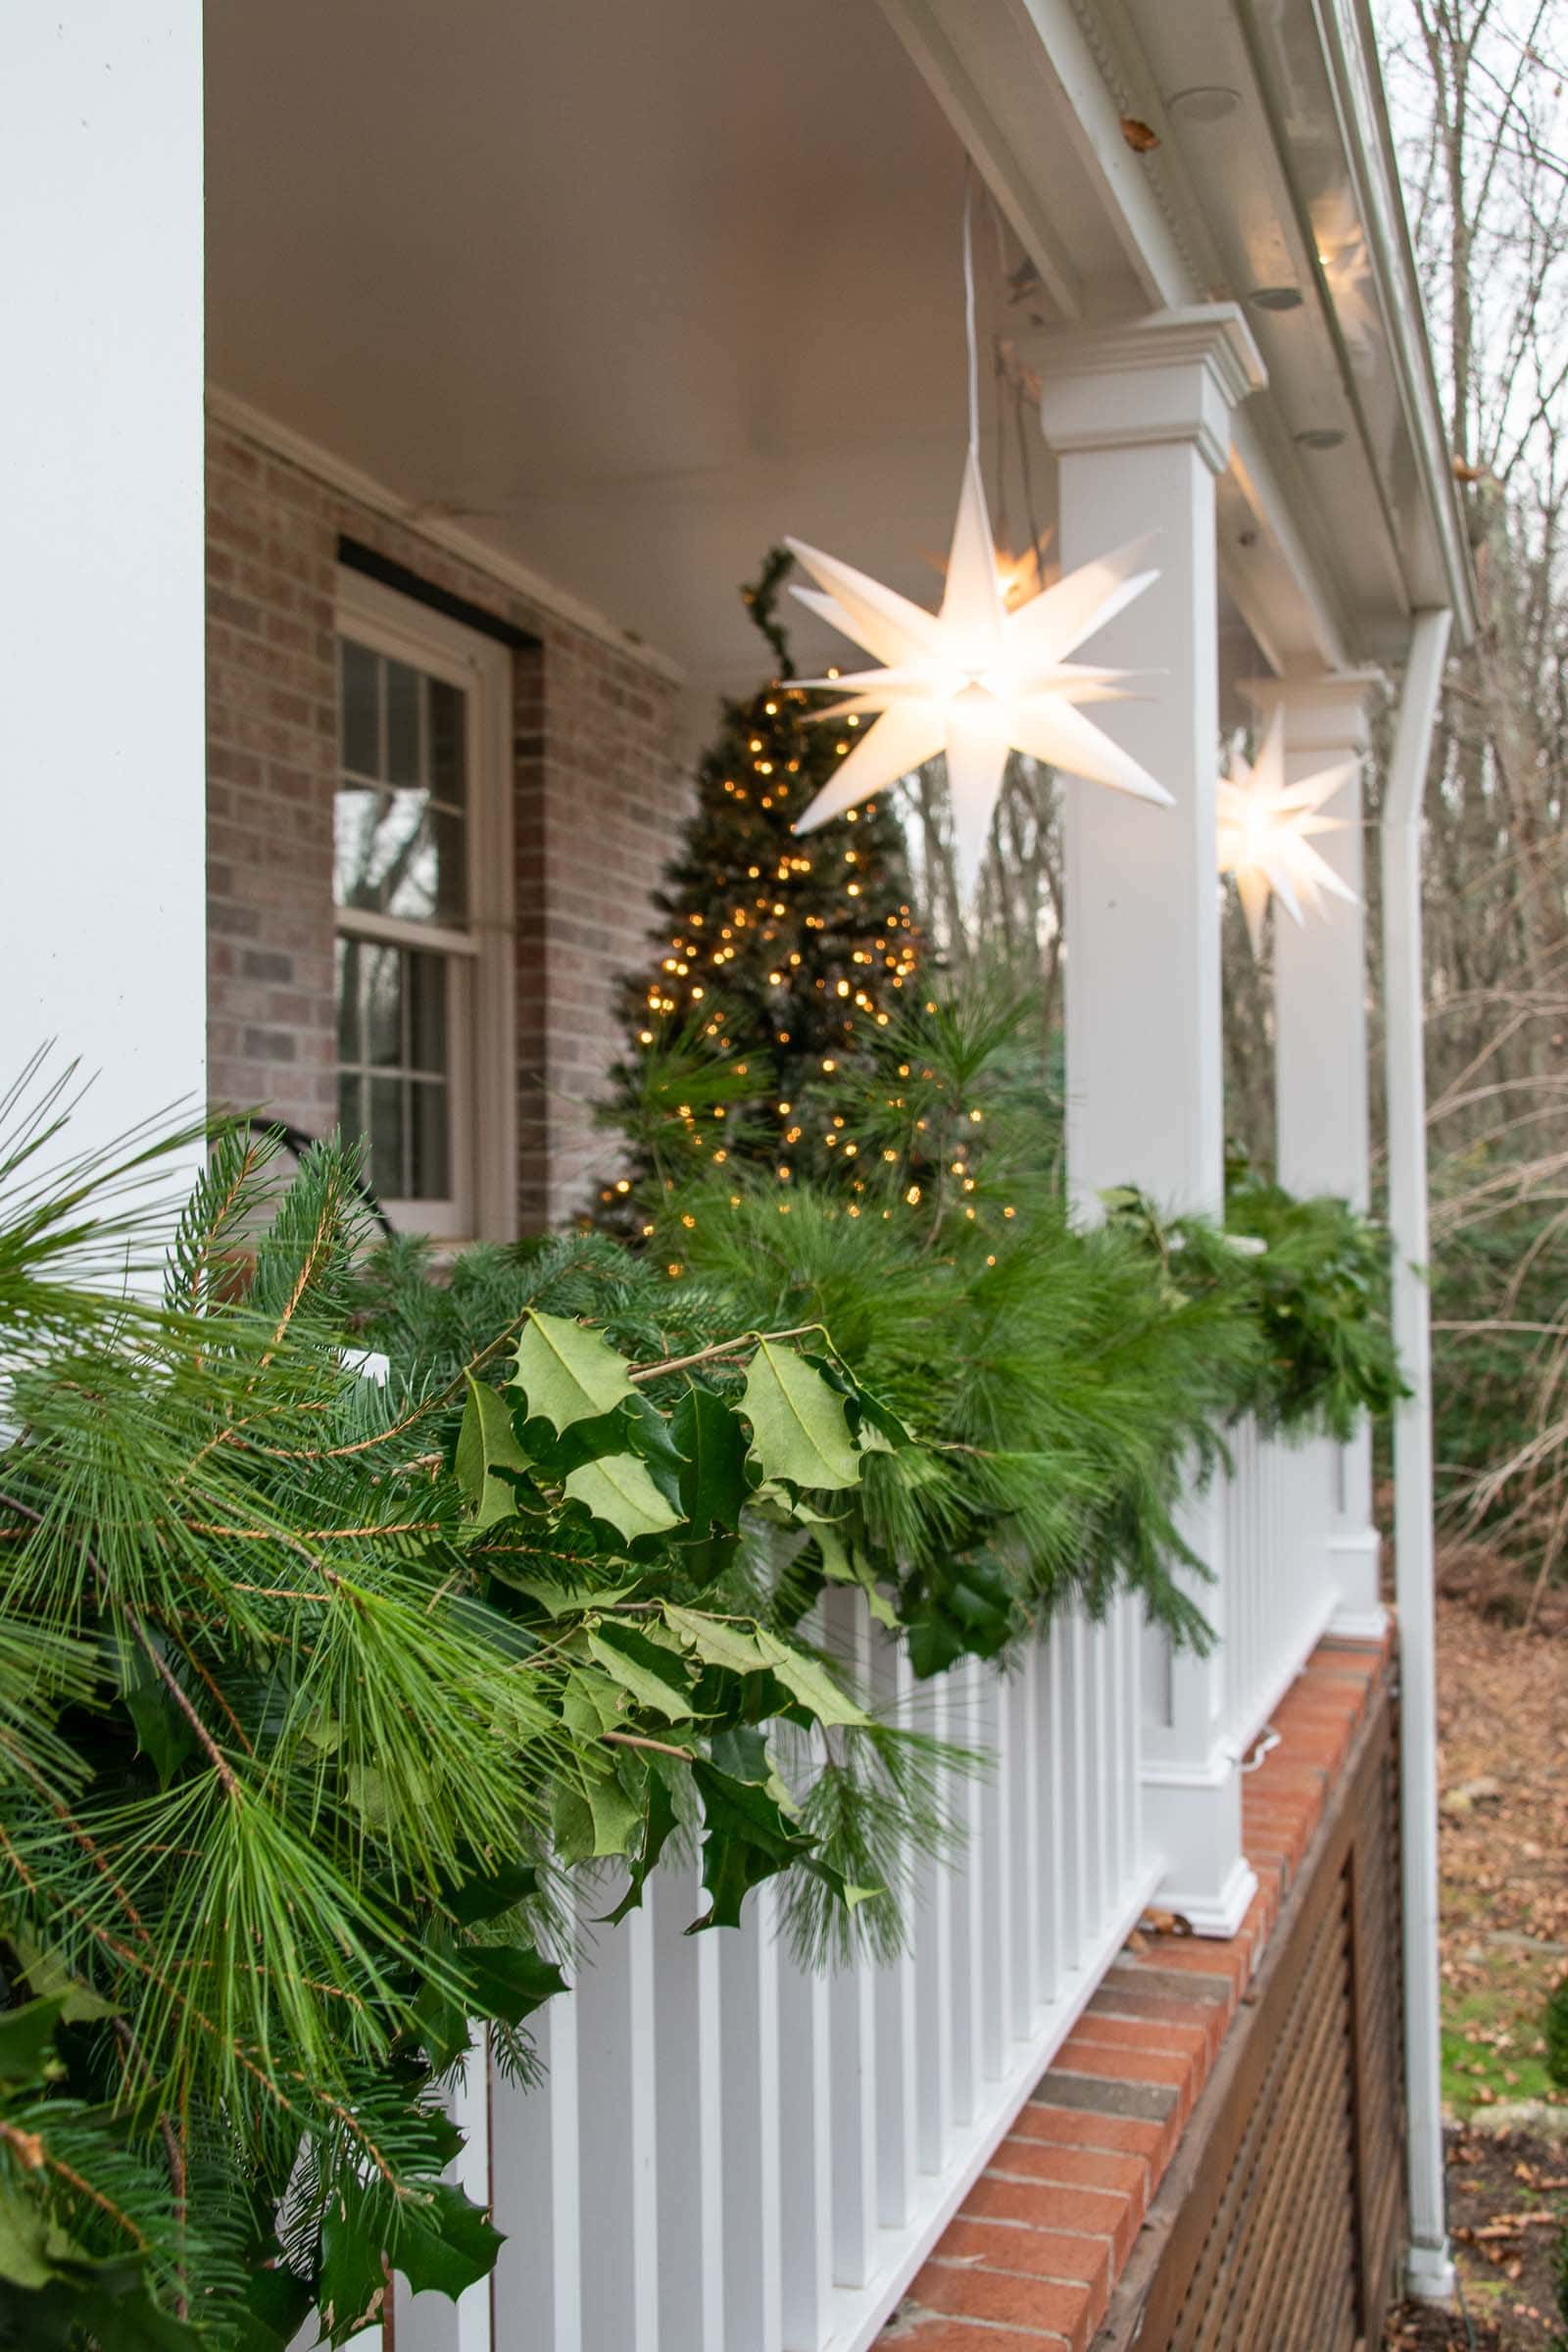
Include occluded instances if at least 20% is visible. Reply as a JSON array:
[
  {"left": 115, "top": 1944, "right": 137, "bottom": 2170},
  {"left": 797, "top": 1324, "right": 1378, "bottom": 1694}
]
[{"left": 882, "top": 0, "right": 1467, "bottom": 668}]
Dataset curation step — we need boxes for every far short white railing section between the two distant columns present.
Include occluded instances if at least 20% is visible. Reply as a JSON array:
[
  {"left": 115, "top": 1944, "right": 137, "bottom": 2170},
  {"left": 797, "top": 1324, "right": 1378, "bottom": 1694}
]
[{"left": 1222, "top": 1416, "right": 1340, "bottom": 1754}]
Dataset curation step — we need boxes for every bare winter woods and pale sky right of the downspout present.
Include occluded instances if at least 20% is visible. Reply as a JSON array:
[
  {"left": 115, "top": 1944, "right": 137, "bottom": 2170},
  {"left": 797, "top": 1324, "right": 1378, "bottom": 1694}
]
[{"left": 1373, "top": 0, "right": 1568, "bottom": 1576}]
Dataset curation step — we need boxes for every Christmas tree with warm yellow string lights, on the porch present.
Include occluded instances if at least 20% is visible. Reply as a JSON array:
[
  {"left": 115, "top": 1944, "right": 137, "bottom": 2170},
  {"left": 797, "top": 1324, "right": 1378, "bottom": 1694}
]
[{"left": 600, "top": 548, "right": 919, "bottom": 1223}]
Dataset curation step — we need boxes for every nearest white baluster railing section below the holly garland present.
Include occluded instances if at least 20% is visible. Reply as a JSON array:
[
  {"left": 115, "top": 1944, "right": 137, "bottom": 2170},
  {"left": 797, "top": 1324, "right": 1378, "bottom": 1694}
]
[{"left": 367, "top": 1592, "right": 1161, "bottom": 2352}]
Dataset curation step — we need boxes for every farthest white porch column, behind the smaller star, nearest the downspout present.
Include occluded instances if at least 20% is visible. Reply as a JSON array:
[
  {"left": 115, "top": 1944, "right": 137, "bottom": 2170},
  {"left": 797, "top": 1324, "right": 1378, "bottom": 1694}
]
[{"left": 1244, "top": 670, "right": 1385, "bottom": 1642}]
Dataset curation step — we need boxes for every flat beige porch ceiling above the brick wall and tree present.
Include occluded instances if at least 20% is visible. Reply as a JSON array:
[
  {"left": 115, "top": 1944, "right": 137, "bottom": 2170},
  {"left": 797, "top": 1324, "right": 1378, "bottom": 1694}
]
[{"left": 207, "top": 0, "right": 1104, "bottom": 714}]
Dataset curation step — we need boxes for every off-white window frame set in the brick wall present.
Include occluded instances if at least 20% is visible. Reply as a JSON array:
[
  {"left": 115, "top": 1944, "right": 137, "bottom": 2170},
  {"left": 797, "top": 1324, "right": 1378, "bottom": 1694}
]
[{"left": 334, "top": 569, "right": 517, "bottom": 1245}]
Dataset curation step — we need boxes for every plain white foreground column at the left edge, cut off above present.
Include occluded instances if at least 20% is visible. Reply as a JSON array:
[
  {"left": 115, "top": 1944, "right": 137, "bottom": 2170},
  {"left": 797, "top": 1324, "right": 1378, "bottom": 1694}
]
[{"left": 0, "top": 0, "right": 207, "bottom": 1166}]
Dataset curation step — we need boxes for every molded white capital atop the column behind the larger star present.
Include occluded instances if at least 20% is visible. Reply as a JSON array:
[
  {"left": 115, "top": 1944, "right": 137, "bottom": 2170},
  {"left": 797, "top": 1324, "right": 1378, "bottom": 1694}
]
[{"left": 1027, "top": 301, "right": 1267, "bottom": 472}]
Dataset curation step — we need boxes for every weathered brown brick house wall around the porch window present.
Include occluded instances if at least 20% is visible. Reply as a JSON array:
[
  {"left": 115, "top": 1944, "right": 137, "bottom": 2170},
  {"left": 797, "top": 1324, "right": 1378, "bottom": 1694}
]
[{"left": 207, "top": 423, "right": 684, "bottom": 1233}]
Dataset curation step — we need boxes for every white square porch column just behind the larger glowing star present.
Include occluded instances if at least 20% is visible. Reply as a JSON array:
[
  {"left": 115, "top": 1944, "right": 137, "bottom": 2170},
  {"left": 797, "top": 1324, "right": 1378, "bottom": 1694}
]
[{"left": 1030, "top": 304, "right": 1262, "bottom": 1936}]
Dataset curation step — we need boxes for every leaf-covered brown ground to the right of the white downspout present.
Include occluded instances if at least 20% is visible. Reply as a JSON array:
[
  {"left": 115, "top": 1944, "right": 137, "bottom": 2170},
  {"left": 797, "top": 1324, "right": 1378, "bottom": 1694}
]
[{"left": 1387, "top": 1552, "right": 1568, "bottom": 2352}]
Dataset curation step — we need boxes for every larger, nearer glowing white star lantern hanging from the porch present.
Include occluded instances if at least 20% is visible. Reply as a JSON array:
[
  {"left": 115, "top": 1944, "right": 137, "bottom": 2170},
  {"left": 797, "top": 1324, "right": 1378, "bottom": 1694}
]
[{"left": 790, "top": 452, "right": 1171, "bottom": 899}]
